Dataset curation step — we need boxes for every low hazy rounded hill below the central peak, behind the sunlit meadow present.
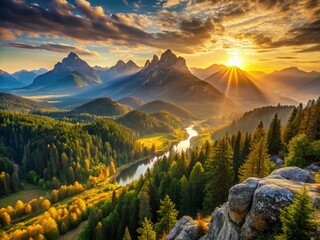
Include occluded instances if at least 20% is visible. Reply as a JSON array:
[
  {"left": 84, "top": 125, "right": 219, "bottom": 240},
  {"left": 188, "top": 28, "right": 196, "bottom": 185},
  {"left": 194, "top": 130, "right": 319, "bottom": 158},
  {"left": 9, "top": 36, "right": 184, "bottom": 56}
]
[{"left": 139, "top": 100, "right": 196, "bottom": 120}]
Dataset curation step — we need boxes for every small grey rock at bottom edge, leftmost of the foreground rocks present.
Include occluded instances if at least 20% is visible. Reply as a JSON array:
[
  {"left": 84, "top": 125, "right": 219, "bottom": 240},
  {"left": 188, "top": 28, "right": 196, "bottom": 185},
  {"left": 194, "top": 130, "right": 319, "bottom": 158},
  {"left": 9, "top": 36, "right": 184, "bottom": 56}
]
[{"left": 166, "top": 216, "right": 201, "bottom": 240}]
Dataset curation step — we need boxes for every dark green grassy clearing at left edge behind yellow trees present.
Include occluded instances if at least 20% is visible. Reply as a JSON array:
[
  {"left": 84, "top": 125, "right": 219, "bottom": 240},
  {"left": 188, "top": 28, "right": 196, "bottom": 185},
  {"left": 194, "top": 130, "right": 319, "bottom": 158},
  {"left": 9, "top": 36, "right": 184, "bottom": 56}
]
[{"left": 0, "top": 183, "right": 47, "bottom": 208}]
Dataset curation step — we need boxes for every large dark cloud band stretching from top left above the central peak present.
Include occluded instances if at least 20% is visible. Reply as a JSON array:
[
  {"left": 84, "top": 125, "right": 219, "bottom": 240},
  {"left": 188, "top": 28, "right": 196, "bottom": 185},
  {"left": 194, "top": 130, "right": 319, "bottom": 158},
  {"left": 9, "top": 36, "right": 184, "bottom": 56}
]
[{"left": 0, "top": 0, "right": 220, "bottom": 53}]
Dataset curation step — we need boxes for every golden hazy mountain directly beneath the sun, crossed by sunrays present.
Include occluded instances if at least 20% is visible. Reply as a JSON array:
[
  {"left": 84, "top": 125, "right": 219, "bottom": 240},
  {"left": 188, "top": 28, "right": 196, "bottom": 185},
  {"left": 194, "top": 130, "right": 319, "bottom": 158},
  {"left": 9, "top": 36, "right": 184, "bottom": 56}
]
[{"left": 206, "top": 67, "right": 296, "bottom": 108}]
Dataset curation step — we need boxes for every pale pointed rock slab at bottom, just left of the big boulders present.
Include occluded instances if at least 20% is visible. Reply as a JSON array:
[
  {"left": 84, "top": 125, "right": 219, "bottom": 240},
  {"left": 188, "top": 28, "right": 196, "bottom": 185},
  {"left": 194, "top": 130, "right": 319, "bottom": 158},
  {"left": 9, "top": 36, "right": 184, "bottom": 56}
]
[{"left": 205, "top": 203, "right": 240, "bottom": 240}]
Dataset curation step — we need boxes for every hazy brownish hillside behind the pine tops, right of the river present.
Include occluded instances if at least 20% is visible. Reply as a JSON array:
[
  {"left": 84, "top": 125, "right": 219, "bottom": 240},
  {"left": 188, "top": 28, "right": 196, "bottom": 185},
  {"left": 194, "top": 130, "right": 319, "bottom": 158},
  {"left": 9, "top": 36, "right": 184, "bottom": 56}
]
[{"left": 212, "top": 106, "right": 293, "bottom": 140}]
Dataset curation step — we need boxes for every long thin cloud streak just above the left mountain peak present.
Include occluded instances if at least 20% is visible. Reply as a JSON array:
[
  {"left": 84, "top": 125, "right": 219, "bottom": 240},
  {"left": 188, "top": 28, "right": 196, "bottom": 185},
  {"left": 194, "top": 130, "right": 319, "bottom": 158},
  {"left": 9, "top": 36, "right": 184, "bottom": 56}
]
[{"left": 0, "top": 42, "right": 100, "bottom": 57}]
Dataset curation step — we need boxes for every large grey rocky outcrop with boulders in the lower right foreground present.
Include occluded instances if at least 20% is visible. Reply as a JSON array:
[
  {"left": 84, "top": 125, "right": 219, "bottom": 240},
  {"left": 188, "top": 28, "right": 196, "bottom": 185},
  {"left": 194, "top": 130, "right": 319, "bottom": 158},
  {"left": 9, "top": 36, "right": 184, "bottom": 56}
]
[{"left": 169, "top": 167, "right": 320, "bottom": 240}]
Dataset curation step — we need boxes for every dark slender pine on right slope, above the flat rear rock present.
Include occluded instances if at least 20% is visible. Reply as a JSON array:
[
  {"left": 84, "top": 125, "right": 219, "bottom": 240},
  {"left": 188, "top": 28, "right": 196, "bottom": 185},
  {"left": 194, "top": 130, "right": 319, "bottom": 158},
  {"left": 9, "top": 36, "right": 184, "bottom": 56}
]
[{"left": 267, "top": 113, "right": 282, "bottom": 156}]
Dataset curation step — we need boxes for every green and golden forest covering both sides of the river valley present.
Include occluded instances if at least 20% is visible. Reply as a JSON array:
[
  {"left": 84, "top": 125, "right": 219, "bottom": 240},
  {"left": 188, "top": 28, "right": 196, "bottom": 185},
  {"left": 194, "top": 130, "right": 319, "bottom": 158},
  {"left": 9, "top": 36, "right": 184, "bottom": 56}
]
[{"left": 0, "top": 98, "right": 320, "bottom": 240}]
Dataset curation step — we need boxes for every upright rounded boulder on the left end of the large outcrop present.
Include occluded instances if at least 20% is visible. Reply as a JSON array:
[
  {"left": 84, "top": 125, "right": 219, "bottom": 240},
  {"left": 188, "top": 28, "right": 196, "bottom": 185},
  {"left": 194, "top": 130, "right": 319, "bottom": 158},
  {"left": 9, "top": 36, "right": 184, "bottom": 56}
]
[{"left": 228, "top": 178, "right": 259, "bottom": 224}]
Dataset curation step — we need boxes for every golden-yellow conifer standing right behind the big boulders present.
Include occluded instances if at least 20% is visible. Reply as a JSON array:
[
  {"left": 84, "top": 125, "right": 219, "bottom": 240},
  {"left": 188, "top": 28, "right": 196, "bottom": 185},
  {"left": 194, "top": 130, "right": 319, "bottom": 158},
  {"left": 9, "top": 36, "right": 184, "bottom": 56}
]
[{"left": 239, "top": 137, "right": 272, "bottom": 181}]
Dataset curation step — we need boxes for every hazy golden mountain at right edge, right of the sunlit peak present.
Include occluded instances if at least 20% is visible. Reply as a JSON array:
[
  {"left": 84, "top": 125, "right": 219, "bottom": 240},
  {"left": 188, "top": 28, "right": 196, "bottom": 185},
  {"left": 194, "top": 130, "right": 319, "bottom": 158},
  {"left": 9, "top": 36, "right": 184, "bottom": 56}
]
[{"left": 260, "top": 67, "right": 320, "bottom": 101}]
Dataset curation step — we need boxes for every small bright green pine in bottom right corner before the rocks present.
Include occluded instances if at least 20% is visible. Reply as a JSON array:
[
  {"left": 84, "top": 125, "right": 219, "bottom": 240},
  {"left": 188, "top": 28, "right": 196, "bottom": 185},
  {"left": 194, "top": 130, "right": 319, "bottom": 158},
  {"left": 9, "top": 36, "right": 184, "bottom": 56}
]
[{"left": 279, "top": 186, "right": 315, "bottom": 240}]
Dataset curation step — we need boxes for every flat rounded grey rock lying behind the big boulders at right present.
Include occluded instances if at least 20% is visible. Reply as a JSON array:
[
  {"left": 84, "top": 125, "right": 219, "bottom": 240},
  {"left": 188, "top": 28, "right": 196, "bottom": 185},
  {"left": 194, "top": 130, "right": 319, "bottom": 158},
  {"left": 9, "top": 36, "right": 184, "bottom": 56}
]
[{"left": 270, "top": 167, "right": 313, "bottom": 183}]
